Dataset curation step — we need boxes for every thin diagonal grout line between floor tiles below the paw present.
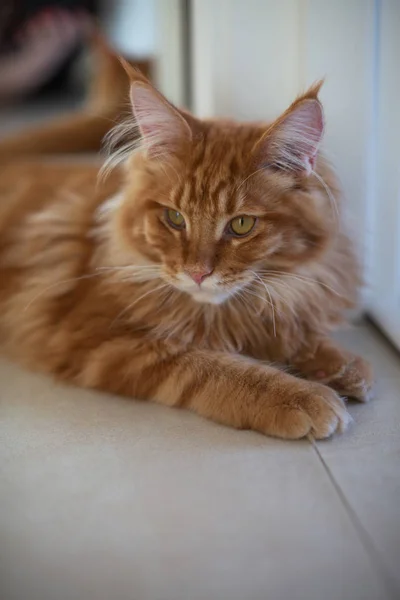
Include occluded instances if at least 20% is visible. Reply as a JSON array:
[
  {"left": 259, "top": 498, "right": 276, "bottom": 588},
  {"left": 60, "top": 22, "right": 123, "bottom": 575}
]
[{"left": 308, "top": 436, "right": 400, "bottom": 600}]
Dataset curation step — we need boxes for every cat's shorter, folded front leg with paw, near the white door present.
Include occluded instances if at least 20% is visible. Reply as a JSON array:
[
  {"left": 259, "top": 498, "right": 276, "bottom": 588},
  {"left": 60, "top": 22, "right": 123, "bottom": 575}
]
[{"left": 292, "top": 339, "right": 373, "bottom": 402}]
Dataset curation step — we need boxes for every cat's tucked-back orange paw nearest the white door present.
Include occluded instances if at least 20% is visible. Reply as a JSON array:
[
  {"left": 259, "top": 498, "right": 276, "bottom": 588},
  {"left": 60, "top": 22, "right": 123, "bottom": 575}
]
[{"left": 314, "top": 356, "right": 374, "bottom": 402}]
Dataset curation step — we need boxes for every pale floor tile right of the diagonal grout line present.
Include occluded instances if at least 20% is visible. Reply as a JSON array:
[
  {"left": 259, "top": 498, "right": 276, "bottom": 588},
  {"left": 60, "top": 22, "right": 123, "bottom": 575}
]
[{"left": 318, "top": 327, "right": 400, "bottom": 597}]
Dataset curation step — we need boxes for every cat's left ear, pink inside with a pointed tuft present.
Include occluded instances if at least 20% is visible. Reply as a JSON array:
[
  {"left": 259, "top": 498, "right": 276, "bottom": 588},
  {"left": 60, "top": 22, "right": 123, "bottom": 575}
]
[{"left": 121, "top": 60, "right": 192, "bottom": 158}]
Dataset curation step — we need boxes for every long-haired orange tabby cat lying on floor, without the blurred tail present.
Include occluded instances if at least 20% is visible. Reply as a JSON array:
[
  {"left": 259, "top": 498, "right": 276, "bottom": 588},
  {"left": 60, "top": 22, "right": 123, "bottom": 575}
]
[{"left": 0, "top": 45, "right": 371, "bottom": 438}]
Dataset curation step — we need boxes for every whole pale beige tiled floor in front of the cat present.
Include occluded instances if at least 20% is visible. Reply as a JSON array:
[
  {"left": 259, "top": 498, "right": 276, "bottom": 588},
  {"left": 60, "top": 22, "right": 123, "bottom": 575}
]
[{"left": 0, "top": 326, "right": 400, "bottom": 600}]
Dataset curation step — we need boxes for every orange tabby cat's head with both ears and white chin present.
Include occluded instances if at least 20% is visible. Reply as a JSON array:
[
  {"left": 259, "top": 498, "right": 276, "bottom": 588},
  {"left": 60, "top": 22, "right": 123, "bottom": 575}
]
[{"left": 108, "top": 61, "right": 332, "bottom": 304}]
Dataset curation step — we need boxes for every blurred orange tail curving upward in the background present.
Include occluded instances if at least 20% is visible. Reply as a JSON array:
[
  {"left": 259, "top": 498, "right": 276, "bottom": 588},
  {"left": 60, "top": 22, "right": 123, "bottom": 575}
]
[{"left": 0, "top": 32, "right": 149, "bottom": 160}]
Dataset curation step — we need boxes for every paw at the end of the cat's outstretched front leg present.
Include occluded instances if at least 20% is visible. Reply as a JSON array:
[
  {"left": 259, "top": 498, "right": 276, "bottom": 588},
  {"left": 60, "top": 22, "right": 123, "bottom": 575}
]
[{"left": 267, "top": 378, "right": 352, "bottom": 439}]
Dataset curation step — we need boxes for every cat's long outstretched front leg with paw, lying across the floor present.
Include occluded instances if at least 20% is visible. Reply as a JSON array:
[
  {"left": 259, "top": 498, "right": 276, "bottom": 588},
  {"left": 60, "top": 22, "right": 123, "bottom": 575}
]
[{"left": 80, "top": 340, "right": 351, "bottom": 439}]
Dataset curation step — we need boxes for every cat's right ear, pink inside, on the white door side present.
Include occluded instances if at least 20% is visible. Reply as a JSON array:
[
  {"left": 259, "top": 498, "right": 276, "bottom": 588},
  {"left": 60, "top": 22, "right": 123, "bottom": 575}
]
[{"left": 255, "top": 81, "right": 324, "bottom": 175}]
